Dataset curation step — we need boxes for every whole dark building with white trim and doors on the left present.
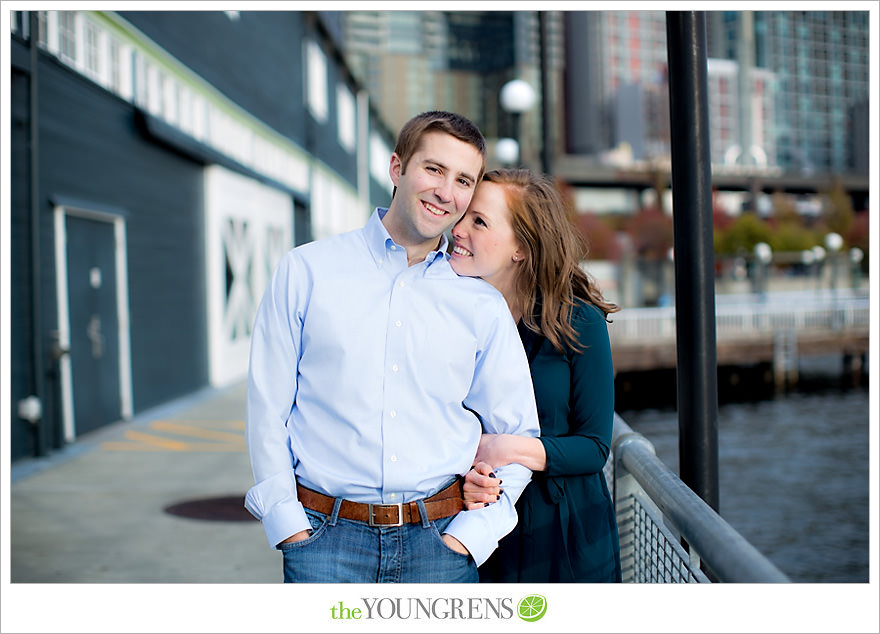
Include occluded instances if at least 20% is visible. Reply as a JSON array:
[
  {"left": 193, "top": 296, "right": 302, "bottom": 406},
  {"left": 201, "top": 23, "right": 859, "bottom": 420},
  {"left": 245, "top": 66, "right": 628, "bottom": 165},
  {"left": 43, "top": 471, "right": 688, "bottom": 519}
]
[{"left": 9, "top": 12, "right": 391, "bottom": 459}]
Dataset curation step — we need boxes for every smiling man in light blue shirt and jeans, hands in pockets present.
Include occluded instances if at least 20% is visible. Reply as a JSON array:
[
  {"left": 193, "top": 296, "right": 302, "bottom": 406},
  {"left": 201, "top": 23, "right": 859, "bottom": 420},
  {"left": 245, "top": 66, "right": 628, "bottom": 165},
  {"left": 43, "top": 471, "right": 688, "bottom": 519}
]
[{"left": 245, "top": 112, "right": 538, "bottom": 583}]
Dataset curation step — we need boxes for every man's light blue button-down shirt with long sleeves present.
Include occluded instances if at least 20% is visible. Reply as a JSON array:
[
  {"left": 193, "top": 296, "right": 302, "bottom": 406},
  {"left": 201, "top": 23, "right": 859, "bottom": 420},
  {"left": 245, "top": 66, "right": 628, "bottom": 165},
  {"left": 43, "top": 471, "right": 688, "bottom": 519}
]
[{"left": 245, "top": 208, "right": 539, "bottom": 565}]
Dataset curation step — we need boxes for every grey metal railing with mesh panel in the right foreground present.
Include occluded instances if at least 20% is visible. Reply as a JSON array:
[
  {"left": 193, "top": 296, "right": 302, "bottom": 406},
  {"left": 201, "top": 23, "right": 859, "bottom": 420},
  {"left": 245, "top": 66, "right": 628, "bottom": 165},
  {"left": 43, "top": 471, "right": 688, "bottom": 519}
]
[{"left": 605, "top": 414, "right": 790, "bottom": 583}]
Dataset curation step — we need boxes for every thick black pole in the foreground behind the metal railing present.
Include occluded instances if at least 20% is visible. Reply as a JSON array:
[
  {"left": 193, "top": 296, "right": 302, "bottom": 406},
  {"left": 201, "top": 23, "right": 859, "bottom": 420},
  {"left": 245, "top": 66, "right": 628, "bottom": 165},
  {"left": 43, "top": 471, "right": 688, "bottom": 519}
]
[{"left": 666, "top": 11, "right": 718, "bottom": 511}]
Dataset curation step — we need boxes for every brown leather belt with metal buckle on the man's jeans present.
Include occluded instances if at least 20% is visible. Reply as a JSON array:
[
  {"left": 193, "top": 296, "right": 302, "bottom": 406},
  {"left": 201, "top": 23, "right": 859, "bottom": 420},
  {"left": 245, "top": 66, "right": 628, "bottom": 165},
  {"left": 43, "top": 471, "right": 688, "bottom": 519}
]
[{"left": 296, "top": 480, "right": 464, "bottom": 526}]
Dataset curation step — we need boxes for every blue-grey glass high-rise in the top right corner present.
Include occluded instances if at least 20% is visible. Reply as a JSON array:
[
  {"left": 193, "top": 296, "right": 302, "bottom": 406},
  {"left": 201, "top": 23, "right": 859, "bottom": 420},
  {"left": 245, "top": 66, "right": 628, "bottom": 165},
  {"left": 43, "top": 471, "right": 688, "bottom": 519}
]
[{"left": 707, "top": 11, "right": 870, "bottom": 173}]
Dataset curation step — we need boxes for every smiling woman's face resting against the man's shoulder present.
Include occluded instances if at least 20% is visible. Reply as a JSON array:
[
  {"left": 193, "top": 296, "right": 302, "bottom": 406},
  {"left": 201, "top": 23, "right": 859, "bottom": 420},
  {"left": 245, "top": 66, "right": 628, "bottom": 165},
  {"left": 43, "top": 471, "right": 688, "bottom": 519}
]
[{"left": 450, "top": 181, "right": 523, "bottom": 293}]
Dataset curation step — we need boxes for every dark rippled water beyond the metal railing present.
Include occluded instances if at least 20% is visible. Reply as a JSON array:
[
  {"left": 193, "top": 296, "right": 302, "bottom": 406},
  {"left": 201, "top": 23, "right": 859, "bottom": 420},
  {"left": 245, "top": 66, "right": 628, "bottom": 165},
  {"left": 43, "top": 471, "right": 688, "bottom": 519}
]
[{"left": 618, "top": 358, "right": 877, "bottom": 583}]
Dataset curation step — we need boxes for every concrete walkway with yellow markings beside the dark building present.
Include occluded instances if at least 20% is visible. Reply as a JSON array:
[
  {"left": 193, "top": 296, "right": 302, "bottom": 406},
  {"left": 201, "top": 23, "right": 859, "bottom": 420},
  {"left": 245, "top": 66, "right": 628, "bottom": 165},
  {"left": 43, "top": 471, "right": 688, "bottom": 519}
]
[{"left": 9, "top": 383, "right": 281, "bottom": 583}]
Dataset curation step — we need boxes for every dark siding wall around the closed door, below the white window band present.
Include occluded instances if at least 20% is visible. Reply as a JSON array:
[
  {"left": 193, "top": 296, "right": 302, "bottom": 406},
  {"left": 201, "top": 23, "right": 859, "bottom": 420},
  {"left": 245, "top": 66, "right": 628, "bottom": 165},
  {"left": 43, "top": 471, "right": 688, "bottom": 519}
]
[{"left": 11, "top": 42, "right": 207, "bottom": 453}]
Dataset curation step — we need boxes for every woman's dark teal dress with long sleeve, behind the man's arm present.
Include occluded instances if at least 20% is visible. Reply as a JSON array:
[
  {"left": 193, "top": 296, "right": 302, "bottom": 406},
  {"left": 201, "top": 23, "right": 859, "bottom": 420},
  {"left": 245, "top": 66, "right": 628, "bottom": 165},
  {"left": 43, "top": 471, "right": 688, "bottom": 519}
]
[{"left": 479, "top": 301, "right": 620, "bottom": 583}]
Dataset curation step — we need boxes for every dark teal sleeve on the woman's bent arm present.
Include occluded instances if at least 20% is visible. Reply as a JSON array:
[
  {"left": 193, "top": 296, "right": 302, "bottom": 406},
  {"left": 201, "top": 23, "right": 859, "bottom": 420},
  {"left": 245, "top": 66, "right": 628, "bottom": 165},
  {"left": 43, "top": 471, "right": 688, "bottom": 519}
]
[{"left": 541, "top": 304, "right": 614, "bottom": 476}]
